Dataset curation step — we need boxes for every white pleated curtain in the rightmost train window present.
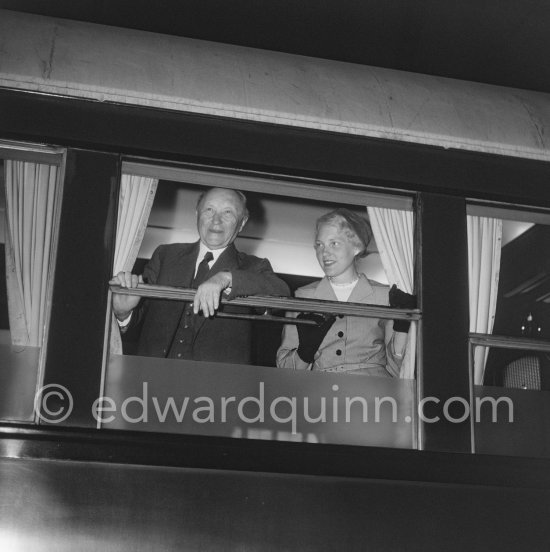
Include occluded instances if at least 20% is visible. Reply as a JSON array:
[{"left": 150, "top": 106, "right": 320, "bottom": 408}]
[{"left": 467, "top": 215, "right": 502, "bottom": 385}]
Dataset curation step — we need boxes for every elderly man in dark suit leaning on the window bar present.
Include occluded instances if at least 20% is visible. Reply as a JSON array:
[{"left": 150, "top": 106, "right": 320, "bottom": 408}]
[{"left": 110, "top": 188, "right": 289, "bottom": 364}]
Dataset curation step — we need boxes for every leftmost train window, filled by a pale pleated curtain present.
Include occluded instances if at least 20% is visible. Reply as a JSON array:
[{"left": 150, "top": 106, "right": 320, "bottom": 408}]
[{"left": 0, "top": 144, "right": 62, "bottom": 422}]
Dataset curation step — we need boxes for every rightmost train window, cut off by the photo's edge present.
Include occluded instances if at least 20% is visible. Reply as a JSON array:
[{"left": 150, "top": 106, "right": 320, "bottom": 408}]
[{"left": 468, "top": 204, "right": 550, "bottom": 456}]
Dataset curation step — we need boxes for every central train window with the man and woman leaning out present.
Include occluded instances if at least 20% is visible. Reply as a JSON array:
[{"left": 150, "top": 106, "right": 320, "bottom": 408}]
[{"left": 103, "top": 163, "right": 419, "bottom": 448}]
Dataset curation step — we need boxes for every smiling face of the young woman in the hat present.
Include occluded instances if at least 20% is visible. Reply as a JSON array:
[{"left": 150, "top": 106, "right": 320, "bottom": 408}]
[{"left": 315, "top": 223, "right": 359, "bottom": 281}]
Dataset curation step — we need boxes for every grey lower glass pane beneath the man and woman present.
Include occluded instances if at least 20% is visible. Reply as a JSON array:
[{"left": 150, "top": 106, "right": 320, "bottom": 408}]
[{"left": 102, "top": 355, "right": 416, "bottom": 448}]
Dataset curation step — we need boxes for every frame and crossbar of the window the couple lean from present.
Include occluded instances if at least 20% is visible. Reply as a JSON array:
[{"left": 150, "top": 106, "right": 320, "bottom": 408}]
[{"left": 102, "top": 156, "right": 422, "bottom": 448}]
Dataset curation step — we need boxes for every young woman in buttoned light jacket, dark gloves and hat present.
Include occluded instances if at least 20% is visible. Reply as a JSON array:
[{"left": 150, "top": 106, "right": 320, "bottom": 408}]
[{"left": 277, "top": 208, "right": 415, "bottom": 377}]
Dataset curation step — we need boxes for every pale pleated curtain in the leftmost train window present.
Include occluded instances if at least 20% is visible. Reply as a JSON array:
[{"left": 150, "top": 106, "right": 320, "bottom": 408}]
[{"left": 4, "top": 160, "right": 58, "bottom": 347}]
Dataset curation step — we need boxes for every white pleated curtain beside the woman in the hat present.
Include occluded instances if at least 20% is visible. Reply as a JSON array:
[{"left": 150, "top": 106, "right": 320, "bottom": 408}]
[{"left": 367, "top": 207, "right": 417, "bottom": 379}]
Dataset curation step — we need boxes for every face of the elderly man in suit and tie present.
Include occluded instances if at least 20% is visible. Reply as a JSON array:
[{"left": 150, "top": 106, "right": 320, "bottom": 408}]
[{"left": 197, "top": 189, "right": 246, "bottom": 249}]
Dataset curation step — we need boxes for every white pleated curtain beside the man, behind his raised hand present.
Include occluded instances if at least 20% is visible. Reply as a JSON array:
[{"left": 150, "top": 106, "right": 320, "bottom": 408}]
[{"left": 111, "top": 174, "right": 158, "bottom": 354}]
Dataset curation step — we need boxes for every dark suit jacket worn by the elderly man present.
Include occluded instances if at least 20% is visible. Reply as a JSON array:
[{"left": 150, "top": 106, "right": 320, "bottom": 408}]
[{"left": 133, "top": 242, "right": 290, "bottom": 364}]
